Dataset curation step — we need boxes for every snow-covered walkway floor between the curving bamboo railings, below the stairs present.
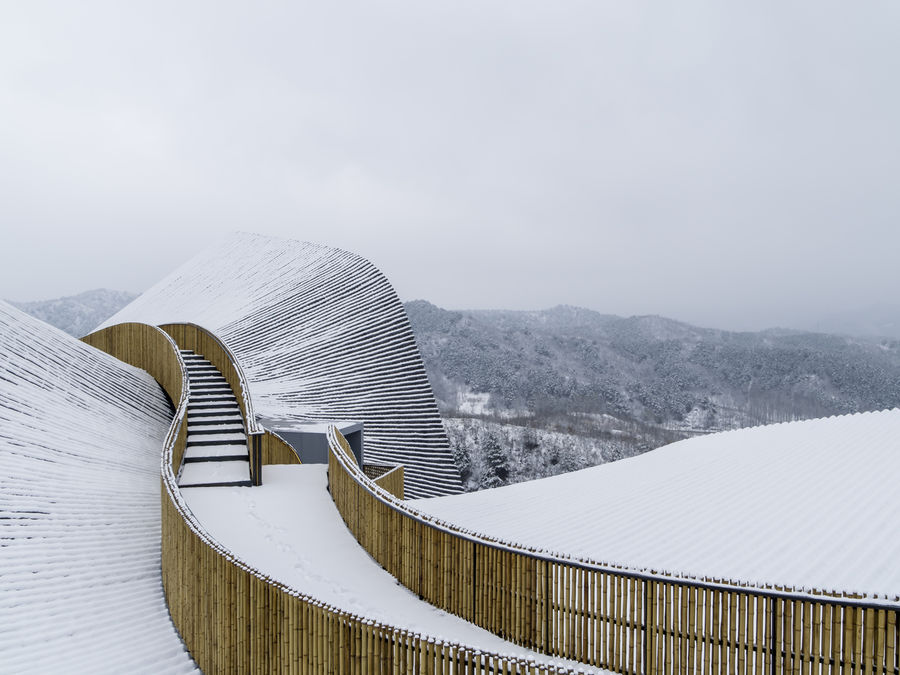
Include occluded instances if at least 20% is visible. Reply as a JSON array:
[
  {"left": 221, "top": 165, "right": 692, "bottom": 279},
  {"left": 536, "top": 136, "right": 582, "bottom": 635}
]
[{"left": 182, "top": 464, "right": 604, "bottom": 673}]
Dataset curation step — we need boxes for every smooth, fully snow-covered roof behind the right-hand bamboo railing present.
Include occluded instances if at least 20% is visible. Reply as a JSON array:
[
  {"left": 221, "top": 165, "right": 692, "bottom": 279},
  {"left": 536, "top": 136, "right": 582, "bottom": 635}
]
[{"left": 410, "top": 409, "right": 900, "bottom": 604}]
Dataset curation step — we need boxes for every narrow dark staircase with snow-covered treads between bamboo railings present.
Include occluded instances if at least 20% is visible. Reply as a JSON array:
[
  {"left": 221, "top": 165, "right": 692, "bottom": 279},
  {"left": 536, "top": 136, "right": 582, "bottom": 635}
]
[{"left": 178, "top": 349, "right": 251, "bottom": 488}]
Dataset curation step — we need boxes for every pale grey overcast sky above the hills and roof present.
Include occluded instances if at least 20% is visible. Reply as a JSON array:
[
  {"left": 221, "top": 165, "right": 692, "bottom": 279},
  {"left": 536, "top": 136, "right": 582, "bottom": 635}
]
[{"left": 0, "top": 0, "right": 900, "bottom": 328}]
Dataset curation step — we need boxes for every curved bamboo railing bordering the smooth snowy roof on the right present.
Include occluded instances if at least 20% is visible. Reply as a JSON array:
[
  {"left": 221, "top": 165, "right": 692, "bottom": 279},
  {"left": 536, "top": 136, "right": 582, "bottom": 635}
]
[{"left": 328, "top": 427, "right": 900, "bottom": 675}]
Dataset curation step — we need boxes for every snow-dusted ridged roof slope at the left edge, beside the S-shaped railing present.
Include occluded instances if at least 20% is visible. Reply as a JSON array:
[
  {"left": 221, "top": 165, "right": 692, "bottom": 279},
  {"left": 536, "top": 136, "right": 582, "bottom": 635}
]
[{"left": 0, "top": 302, "right": 198, "bottom": 673}]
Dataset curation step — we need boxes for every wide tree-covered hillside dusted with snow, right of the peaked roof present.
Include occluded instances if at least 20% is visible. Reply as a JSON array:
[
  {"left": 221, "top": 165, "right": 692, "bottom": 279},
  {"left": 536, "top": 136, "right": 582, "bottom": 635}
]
[{"left": 406, "top": 300, "right": 900, "bottom": 434}]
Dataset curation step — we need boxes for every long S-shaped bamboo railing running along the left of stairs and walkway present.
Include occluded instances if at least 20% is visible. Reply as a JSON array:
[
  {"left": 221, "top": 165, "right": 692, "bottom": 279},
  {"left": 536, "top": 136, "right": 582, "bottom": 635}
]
[{"left": 83, "top": 324, "right": 574, "bottom": 675}]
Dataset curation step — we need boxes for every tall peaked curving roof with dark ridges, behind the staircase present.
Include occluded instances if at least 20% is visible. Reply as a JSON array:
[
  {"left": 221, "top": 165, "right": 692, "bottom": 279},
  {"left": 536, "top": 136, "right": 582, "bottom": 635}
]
[{"left": 104, "top": 233, "right": 462, "bottom": 497}]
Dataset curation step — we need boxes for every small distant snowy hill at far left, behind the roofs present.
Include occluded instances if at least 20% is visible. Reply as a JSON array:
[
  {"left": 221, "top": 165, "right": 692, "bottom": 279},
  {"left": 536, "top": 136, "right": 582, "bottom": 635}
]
[{"left": 9, "top": 288, "right": 138, "bottom": 338}]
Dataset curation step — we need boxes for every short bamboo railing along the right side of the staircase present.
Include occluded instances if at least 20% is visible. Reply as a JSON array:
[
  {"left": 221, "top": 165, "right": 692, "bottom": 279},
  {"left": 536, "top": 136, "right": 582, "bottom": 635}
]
[{"left": 160, "top": 323, "right": 300, "bottom": 485}]
